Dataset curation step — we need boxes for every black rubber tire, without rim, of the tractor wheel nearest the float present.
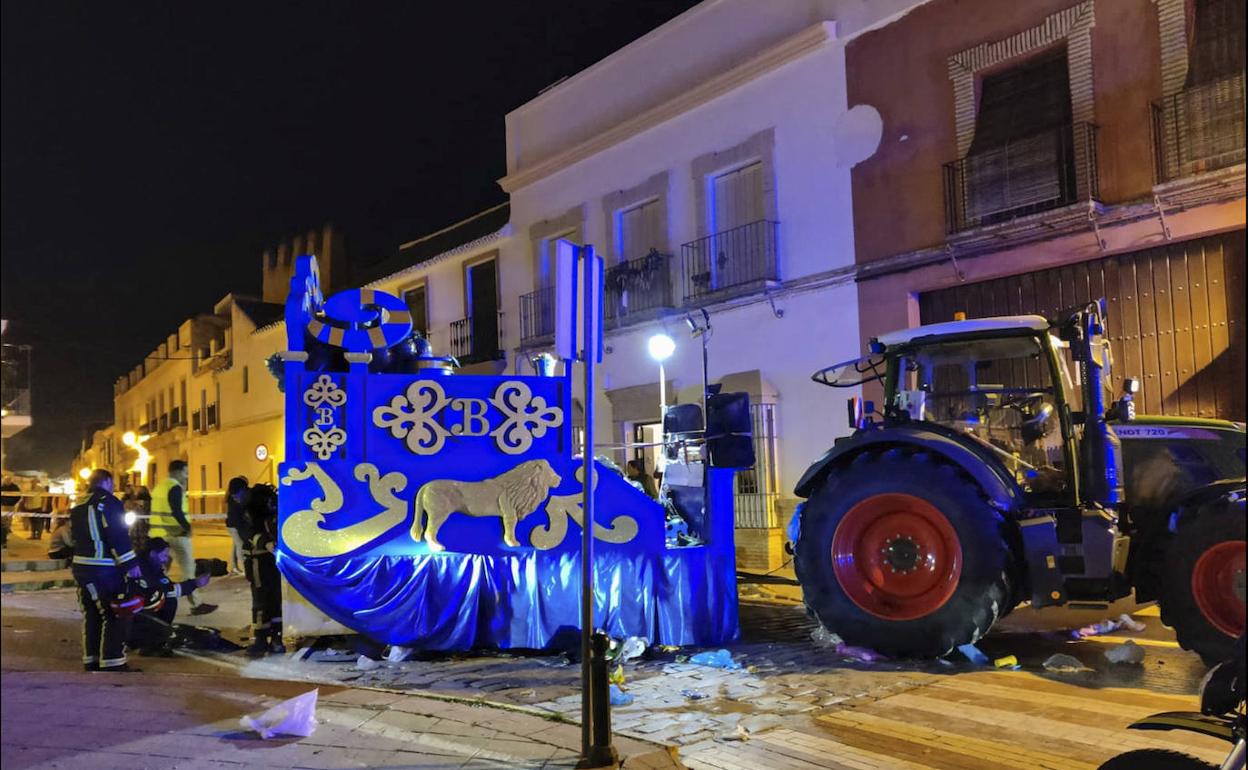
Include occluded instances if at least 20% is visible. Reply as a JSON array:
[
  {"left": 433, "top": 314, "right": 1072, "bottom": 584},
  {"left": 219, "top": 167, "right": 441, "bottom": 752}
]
[{"left": 794, "top": 448, "right": 1021, "bottom": 658}]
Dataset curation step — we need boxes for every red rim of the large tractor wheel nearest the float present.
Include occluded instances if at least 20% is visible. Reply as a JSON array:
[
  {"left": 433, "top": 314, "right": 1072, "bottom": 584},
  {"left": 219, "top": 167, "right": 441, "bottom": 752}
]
[{"left": 832, "top": 493, "right": 962, "bottom": 620}]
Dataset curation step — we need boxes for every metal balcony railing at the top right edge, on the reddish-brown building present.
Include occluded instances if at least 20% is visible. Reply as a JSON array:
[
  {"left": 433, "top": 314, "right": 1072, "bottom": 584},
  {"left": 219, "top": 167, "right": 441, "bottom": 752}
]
[{"left": 1153, "top": 72, "right": 1244, "bottom": 182}]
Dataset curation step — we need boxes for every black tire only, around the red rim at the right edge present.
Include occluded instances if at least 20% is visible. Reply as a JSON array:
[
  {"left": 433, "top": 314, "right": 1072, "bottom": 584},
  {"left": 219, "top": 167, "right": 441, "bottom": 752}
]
[{"left": 1161, "top": 497, "right": 1244, "bottom": 665}]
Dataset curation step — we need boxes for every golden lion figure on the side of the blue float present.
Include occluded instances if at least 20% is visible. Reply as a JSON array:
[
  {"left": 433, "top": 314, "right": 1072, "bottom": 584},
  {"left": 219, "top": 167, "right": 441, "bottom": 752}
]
[{"left": 412, "top": 459, "right": 560, "bottom": 550}]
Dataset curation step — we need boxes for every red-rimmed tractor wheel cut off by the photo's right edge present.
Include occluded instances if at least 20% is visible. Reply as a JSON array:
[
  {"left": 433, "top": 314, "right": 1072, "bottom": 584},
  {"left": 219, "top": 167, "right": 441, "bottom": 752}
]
[{"left": 1161, "top": 498, "right": 1244, "bottom": 665}]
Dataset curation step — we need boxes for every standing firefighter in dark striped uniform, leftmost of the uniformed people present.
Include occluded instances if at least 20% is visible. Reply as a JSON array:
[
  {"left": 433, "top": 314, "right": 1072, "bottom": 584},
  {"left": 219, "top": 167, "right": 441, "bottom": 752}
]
[{"left": 70, "top": 468, "right": 142, "bottom": 671}]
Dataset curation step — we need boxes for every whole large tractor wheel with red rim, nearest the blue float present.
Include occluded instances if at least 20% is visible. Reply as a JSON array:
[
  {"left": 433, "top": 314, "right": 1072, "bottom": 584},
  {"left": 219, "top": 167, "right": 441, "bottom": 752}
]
[{"left": 795, "top": 449, "right": 1017, "bottom": 658}]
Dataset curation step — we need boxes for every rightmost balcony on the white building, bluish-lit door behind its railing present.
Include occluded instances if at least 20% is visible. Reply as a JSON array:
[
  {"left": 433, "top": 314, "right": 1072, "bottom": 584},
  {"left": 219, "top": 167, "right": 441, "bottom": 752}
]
[{"left": 680, "top": 220, "right": 780, "bottom": 305}]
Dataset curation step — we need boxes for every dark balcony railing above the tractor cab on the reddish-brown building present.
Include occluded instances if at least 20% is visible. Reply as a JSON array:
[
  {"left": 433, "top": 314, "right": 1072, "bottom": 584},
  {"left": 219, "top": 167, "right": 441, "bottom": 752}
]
[{"left": 945, "top": 124, "right": 1099, "bottom": 233}]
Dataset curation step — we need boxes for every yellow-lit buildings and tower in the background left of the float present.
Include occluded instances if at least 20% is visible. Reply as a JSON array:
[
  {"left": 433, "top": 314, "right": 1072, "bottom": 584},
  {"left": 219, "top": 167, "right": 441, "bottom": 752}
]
[{"left": 72, "top": 226, "right": 342, "bottom": 513}]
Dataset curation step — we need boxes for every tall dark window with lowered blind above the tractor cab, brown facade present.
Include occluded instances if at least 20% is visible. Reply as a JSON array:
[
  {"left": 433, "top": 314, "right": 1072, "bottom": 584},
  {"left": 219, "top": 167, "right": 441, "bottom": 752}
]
[{"left": 965, "top": 50, "right": 1077, "bottom": 225}]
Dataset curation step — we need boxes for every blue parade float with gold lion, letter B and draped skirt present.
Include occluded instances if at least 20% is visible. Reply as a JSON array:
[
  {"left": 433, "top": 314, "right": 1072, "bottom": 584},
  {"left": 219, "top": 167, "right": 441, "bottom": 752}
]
[{"left": 277, "top": 256, "right": 739, "bottom": 650}]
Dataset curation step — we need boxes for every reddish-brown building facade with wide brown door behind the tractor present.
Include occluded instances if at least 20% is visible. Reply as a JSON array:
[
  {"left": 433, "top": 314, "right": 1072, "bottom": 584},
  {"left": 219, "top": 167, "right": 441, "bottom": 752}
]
[{"left": 847, "top": 0, "right": 1244, "bottom": 421}]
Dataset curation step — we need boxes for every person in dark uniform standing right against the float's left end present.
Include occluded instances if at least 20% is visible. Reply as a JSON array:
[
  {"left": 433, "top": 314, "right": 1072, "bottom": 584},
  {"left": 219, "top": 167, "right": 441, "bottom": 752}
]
[{"left": 246, "top": 484, "right": 286, "bottom": 656}]
